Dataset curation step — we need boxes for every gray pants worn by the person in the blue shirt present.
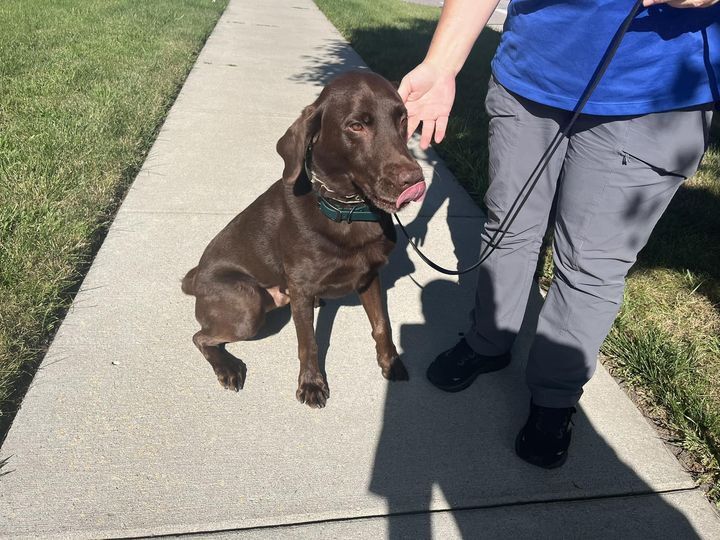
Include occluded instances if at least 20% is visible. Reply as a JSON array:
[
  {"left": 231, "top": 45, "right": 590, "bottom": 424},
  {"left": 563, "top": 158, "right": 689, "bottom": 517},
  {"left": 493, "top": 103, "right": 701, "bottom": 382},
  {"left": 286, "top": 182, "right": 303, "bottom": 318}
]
[{"left": 465, "top": 75, "right": 712, "bottom": 407}]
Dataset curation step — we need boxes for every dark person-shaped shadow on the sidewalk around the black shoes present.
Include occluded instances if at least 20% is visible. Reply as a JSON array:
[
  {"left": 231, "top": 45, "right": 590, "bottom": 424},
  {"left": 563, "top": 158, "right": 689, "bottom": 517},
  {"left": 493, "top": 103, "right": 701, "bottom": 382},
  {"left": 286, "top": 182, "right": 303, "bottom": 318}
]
[{"left": 368, "top": 268, "right": 698, "bottom": 540}]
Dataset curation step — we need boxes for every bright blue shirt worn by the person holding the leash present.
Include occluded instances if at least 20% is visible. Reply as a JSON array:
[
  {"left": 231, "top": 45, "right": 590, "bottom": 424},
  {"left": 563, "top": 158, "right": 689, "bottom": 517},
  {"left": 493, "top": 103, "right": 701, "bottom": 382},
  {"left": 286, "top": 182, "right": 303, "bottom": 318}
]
[{"left": 492, "top": 0, "right": 720, "bottom": 115}]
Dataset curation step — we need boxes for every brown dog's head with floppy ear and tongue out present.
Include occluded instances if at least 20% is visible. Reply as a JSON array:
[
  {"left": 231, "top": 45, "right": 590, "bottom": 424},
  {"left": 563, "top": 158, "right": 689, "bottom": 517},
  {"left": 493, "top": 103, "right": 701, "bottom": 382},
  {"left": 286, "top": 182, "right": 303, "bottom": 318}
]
[{"left": 277, "top": 72, "right": 425, "bottom": 212}]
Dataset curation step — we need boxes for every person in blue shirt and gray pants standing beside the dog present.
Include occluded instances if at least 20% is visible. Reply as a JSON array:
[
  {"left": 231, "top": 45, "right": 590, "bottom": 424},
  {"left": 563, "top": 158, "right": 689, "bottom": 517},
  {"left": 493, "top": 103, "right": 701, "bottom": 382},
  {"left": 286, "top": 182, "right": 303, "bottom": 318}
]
[{"left": 398, "top": 0, "right": 720, "bottom": 468}]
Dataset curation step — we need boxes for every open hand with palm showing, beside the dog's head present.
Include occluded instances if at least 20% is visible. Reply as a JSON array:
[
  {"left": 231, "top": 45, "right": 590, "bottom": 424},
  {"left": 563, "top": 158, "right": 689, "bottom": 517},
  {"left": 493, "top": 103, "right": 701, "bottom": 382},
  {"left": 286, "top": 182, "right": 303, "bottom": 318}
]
[{"left": 398, "top": 62, "right": 455, "bottom": 150}]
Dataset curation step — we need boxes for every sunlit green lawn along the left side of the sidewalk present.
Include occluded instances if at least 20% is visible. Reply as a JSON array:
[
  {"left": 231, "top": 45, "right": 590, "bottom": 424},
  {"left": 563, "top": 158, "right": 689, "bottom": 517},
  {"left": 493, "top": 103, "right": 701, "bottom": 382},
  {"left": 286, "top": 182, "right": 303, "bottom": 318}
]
[{"left": 0, "top": 0, "right": 227, "bottom": 441}]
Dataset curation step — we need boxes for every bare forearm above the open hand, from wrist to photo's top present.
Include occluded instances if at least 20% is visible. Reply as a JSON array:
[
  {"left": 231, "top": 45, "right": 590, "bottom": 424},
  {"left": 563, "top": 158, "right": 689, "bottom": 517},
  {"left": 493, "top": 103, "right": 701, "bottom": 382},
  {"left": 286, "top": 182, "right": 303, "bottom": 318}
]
[{"left": 425, "top": 0, "right": 499, "bottom": 75}]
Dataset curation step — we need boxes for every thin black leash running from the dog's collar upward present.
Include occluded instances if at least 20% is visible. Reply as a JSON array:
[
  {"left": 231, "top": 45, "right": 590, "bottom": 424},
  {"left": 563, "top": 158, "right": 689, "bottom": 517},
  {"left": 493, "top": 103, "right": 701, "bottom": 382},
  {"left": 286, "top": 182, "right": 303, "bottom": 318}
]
[{"left": 393, "top": 0, "right": 643, "bottom": 276}]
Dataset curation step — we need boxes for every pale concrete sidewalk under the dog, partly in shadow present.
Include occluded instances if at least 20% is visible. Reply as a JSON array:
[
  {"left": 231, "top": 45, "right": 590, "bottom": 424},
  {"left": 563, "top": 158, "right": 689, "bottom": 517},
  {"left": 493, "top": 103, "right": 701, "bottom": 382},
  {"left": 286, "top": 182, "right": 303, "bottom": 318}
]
[{"left": 0, "top": 0, "right": 720, "bottom": 539}]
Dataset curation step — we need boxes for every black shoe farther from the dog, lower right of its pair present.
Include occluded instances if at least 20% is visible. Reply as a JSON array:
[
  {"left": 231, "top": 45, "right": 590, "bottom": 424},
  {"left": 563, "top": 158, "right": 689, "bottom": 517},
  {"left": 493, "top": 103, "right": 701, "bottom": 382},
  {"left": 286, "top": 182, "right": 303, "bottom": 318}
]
[{"left": 515, "top": 401, "right": 577, "bottom": 469}]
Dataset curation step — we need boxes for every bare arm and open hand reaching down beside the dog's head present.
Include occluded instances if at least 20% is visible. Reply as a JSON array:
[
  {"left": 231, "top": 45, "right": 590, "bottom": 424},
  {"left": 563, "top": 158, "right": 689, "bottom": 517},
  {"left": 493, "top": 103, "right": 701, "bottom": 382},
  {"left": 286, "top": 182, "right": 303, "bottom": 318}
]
[{"left": 398, "top": 0, "right": 499, "bottom": 148}]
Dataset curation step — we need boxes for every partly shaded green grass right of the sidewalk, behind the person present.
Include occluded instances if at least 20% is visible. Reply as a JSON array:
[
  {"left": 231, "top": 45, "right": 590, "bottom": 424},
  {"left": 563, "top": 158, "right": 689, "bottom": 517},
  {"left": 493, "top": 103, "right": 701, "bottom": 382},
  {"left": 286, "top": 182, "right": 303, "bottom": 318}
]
[{"left": 316, "top": 0, "right": 720, "bottom": 502}]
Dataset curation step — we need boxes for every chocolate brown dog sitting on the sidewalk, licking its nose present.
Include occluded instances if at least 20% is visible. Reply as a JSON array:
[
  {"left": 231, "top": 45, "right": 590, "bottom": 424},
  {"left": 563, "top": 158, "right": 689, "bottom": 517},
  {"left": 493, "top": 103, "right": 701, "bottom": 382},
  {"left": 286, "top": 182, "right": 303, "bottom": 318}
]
[{"left": 182, "top": 72, "right": 425, "bottom": 407}]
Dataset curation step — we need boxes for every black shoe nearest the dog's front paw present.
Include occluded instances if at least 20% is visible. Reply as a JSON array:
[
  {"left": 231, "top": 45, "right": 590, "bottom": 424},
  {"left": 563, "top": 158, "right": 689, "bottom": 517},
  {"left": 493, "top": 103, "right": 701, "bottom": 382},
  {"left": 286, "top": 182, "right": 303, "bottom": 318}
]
[{"left": 427, "top": 338, "right": 510, "bottom": 392}]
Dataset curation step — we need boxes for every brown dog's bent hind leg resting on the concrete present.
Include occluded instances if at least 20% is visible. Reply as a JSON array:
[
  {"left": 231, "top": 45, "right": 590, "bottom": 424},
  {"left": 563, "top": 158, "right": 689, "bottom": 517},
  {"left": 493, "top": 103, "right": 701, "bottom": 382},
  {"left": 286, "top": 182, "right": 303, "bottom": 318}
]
[{"left": 193, "top": 277, "right": 267, "bottom": 392}]
